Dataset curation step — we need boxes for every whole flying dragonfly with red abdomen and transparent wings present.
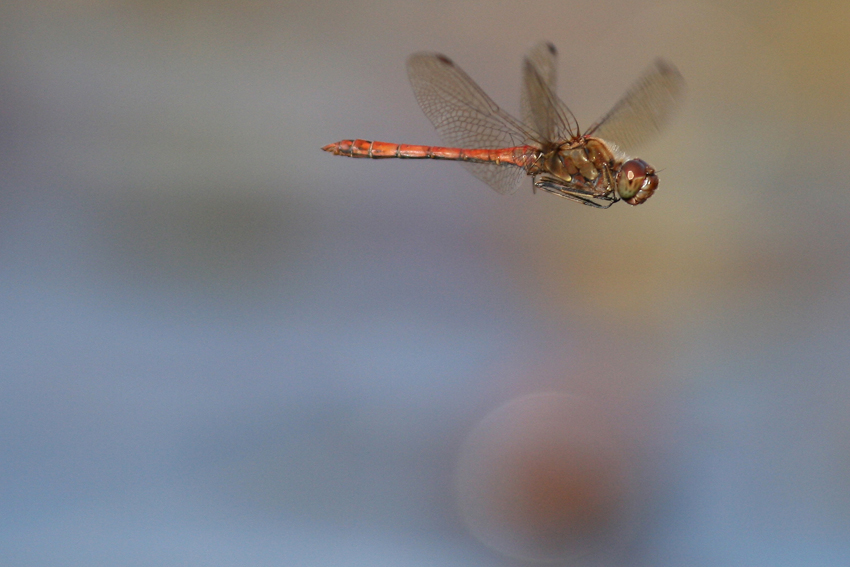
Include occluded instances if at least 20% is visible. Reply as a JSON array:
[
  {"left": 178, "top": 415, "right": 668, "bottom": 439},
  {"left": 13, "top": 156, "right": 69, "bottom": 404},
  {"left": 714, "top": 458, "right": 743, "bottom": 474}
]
[{"left": 322, "top": 42, "right": 685, "bottom": 209}]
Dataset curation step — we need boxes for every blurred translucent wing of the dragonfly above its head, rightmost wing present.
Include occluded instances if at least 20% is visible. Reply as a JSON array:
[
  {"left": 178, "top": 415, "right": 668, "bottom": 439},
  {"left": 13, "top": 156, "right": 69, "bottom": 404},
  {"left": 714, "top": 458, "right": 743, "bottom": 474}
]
[{"left": 586, "top": 59, "right": 685, "bottom": 152}]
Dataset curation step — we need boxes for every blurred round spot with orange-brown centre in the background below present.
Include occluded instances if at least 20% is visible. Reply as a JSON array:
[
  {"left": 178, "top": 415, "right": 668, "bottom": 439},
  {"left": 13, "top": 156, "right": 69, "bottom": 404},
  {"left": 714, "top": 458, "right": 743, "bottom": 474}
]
[{"left": 457, "top": 394, "right": 629, "bottom": 561}]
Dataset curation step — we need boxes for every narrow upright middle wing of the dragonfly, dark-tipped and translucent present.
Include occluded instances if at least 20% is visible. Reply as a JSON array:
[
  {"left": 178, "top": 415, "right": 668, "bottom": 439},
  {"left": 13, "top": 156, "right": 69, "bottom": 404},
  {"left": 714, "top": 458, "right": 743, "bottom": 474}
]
[{"left": 521, "top": 42, "right": 579, "bottom": 143}]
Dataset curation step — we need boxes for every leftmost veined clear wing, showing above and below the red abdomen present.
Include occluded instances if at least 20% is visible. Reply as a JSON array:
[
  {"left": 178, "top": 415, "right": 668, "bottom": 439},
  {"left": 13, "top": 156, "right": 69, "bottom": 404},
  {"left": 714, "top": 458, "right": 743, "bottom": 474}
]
[{"left": 407, "top": 53, "right": 539, "bottom": 194}]
